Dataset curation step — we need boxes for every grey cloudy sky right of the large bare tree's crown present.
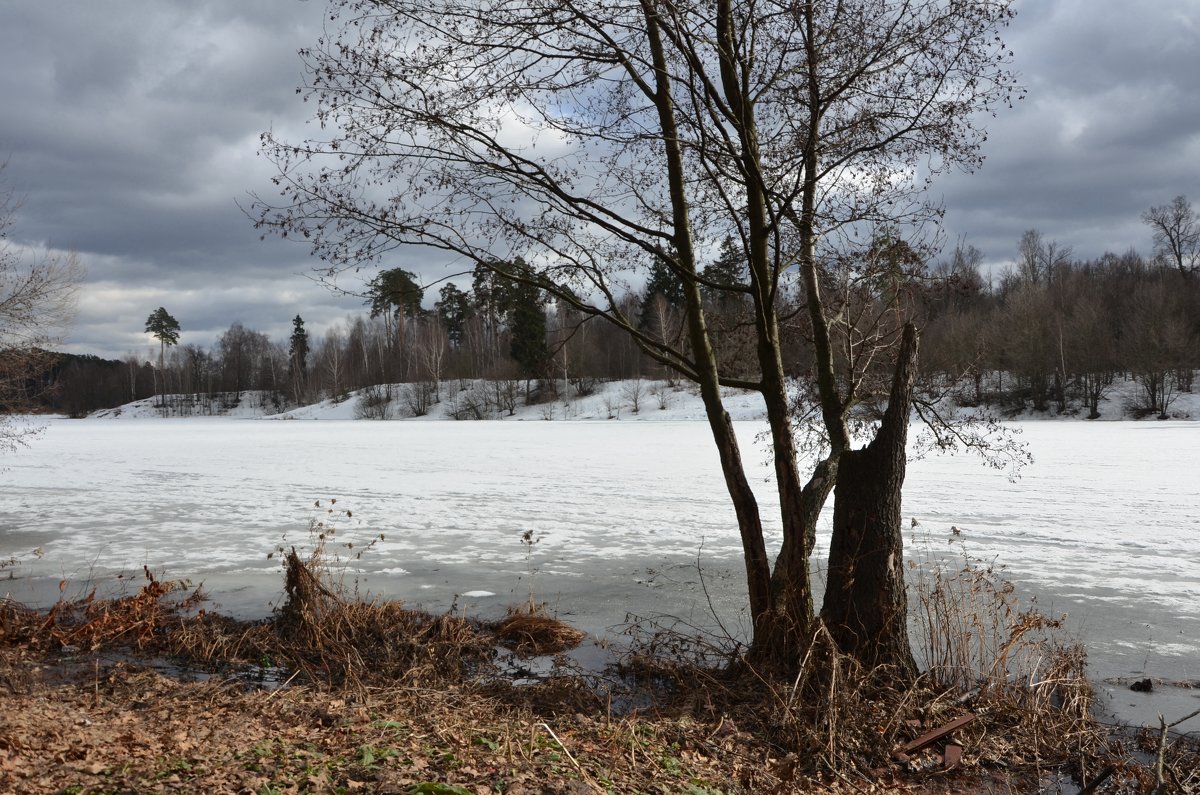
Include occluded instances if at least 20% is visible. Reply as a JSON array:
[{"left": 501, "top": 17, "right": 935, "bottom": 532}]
[{"left": 937, "top": 0, "right": 1200, "bottom": 268}]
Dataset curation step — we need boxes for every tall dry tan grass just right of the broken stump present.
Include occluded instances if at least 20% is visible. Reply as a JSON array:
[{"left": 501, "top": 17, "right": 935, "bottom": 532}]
[{"left": 910, "top": 539, "right": 1145, "bottom": 791}]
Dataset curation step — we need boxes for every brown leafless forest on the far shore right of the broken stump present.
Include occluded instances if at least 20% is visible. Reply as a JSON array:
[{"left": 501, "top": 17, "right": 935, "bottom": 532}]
[{"left": 923, "top": 218, "right": 1200, "bottom": 419}]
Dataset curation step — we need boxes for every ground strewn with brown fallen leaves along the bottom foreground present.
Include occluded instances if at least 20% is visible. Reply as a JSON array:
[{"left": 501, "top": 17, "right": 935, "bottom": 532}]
[{"left": 7, "top": 646, "right": 1152, "bottom": 795}]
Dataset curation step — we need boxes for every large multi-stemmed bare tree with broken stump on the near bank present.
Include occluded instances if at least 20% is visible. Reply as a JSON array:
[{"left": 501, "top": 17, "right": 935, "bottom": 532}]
[{"left": 256, "top": 0, "right": 1014, "bottom": 669}]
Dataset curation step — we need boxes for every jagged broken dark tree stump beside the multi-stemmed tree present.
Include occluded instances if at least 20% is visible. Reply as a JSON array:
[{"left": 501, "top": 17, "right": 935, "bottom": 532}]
[{"left": 821, "top": 323, "right": 917, "bottom": 676}]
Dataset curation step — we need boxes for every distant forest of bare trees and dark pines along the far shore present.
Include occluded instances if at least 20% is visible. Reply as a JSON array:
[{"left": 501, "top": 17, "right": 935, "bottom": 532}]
[{"left": 11, "top": 231, "right": 1200, "bottom": 417}]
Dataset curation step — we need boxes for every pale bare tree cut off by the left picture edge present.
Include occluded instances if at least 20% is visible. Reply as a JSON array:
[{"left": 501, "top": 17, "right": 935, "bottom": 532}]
[{"left": 0, "top": 165, "right": 83, "bottom": 450}]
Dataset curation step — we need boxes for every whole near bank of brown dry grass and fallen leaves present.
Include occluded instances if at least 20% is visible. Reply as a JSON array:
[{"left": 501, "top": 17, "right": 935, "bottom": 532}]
[{"left": 0, "top": 551, "right": 1196, "bottom": 793}]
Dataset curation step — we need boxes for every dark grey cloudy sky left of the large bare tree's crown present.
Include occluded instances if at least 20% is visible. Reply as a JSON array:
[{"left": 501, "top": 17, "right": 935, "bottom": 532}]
[{"left": 0, "top": 0, "right": 355, "bottom": 355}]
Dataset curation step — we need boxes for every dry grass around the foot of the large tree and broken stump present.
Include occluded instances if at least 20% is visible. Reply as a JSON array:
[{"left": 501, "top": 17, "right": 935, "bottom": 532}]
[{"left": 600, "top": 538, "right": 1171, "bottom": 793}]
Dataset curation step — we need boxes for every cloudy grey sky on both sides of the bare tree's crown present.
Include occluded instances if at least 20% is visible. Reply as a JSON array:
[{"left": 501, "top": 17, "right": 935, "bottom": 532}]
[{"left": 0, "top": 0, "right": 1200, "bottom": 358}]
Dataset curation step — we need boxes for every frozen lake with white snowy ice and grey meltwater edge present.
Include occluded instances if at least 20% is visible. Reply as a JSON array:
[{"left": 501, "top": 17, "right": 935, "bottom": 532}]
[{"left": 0, "top": 419, "right": 1200, "bottom": 730}]
